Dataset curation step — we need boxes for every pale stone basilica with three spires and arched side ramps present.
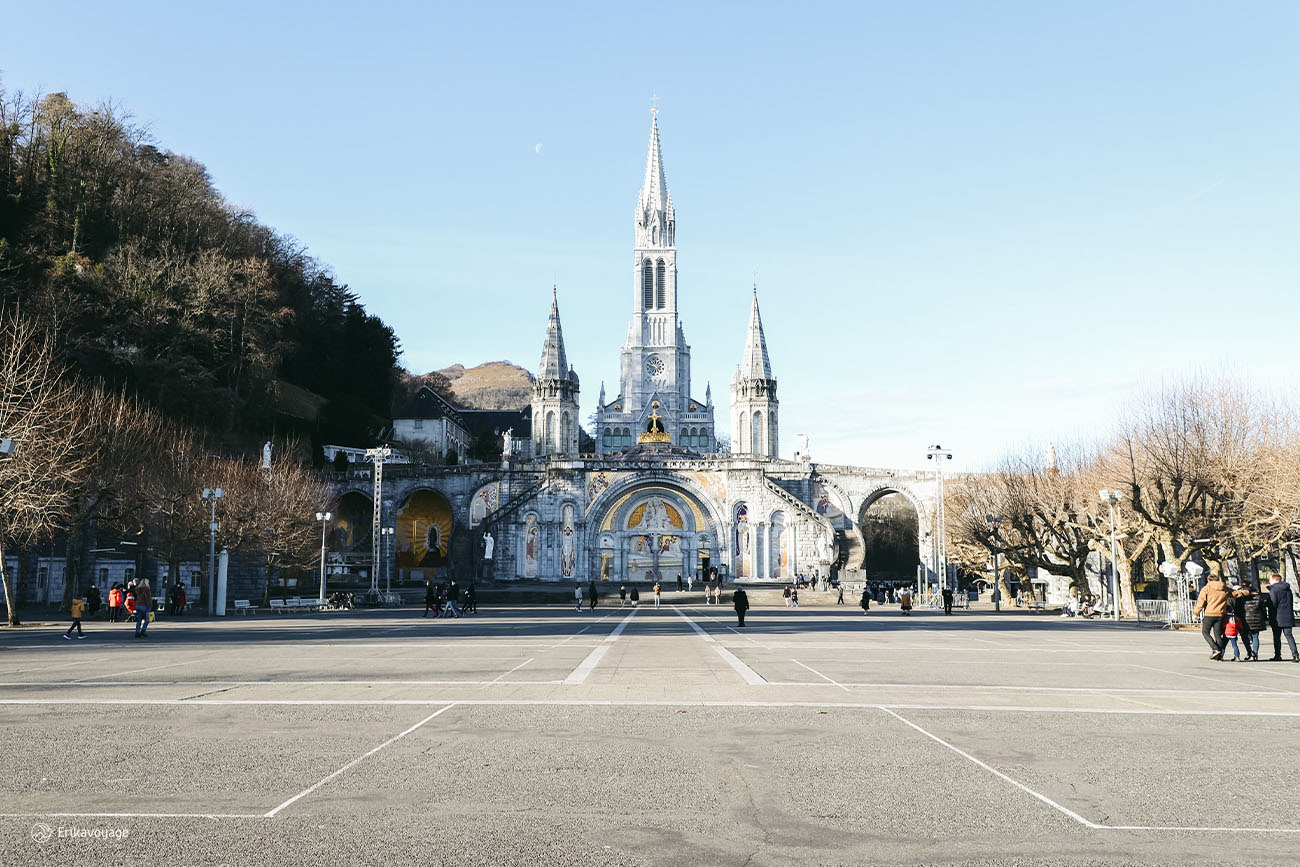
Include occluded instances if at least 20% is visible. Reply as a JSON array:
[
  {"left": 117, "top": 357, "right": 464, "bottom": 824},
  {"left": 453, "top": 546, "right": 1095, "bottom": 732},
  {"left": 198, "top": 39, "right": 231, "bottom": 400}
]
[{"left": 332, "top": 112, "right": 935, "bottom": 582}]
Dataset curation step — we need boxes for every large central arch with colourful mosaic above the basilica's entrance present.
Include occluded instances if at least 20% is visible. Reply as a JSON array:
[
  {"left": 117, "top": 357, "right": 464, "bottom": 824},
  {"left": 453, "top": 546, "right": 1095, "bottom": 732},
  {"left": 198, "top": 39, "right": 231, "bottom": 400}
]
[{"left": 586, "top": 472, "right": 731, "bottom": 581}]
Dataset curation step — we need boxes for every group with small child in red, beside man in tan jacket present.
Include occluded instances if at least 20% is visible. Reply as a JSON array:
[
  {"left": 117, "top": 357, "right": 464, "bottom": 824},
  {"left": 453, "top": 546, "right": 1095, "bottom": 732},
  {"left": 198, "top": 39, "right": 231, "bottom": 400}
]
[{"left": 1192, "top": 572, "right": 1300, "bottom": 663}]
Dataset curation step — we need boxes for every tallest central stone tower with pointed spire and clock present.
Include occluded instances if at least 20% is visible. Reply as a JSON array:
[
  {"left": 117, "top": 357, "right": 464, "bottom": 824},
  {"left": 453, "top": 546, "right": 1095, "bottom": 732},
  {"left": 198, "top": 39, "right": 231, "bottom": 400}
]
[{"left": 595, "top": 109, "right": 716, "bottom": 454}]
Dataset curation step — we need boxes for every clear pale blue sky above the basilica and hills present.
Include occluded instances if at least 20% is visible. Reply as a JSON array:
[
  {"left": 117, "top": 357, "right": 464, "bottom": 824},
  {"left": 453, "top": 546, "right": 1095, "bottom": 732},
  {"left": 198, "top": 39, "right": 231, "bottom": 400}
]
[{"left": 0, "top": 0, "right": 1300, "bottom": 468}]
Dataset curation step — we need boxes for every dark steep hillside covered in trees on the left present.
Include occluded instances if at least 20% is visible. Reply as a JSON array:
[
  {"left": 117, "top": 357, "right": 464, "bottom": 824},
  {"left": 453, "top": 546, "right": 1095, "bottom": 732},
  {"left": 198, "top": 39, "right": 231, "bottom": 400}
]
[{"left": 0, "top": 88, "right": 398, "bottom": 443}]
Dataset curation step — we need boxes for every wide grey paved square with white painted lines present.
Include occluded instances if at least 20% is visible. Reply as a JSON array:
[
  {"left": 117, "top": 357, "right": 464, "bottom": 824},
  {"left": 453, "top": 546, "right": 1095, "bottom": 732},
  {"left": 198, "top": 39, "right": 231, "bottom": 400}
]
[{"left": 0, "top": 608, "right": 1300, "bottom": 867}]
